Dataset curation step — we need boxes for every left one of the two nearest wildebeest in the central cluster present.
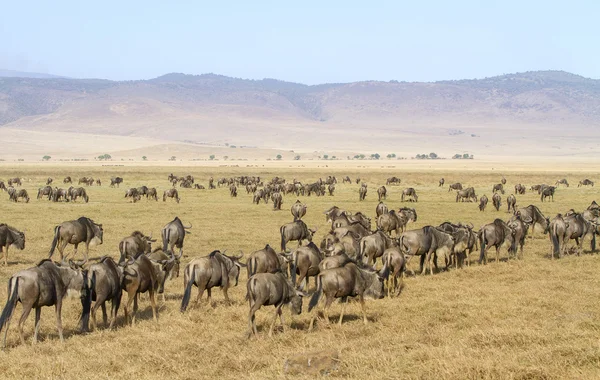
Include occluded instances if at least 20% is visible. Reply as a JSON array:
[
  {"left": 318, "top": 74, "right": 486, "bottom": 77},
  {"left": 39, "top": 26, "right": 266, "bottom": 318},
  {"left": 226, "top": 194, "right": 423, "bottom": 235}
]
[{"left": 246, "top": 272, "right": 305, "bottom": 338}]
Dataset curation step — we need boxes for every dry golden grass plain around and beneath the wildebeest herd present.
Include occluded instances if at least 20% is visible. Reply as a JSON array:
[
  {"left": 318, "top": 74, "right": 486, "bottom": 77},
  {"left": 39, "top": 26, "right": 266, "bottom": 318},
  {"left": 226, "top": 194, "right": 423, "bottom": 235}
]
[{"left": 0, "top": 165, "right": 600, "bottom": 379}]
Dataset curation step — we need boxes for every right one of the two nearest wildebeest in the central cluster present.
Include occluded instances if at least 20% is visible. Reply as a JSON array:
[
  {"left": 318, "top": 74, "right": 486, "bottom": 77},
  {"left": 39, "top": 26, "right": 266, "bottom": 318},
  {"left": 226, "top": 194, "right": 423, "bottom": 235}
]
[{"left": 308, "top": 263, "right": 388, "bottom": 331}]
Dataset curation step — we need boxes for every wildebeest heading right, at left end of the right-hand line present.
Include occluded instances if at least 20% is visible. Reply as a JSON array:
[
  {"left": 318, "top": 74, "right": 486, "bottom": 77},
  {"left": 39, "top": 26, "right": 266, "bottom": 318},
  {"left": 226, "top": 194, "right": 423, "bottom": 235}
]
[{"left": 400, "top": 226, "right": 454, "bottom": 275}]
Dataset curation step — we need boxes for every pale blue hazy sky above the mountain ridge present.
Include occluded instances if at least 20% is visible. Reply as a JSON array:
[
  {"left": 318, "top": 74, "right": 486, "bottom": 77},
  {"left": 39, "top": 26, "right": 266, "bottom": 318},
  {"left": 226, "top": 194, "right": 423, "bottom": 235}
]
[{"left": 0, "top": 0, "right": 600, "bottom": 84}]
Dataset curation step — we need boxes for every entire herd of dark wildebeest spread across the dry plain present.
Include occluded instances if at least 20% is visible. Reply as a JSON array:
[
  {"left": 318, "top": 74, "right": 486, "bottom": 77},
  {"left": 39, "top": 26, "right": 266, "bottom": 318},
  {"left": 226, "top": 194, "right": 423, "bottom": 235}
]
[{"left": 0, "top": 174, "right": 600, "bottom": 345}]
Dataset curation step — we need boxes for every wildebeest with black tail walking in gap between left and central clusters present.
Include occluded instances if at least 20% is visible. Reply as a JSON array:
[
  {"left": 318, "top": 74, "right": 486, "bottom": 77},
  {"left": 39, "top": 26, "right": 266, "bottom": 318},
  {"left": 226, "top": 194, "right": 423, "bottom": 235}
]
[{"left": 180, "top": 251, "right": 245, "bottom": 313}]
